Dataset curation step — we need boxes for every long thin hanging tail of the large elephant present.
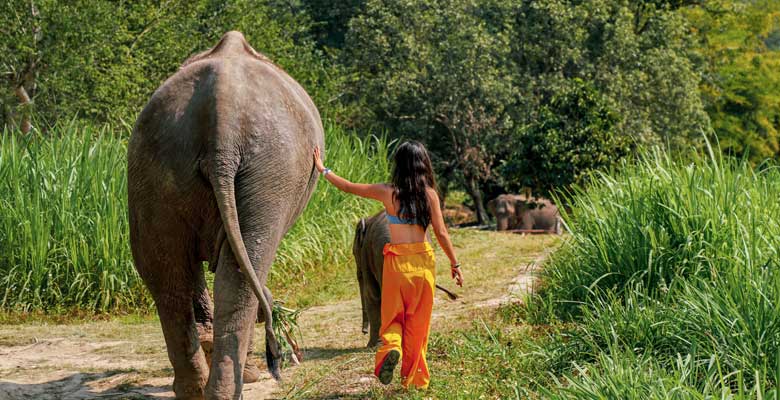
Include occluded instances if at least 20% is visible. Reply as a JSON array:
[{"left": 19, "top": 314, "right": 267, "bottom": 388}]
[{"left": 212, "top": 173, "right": 282, "bottom": 380}]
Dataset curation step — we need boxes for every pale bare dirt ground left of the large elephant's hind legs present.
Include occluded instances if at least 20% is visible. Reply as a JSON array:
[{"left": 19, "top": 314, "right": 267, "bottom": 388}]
[{"left": 0, "top": 321, "right": 276, "bottom": 400}]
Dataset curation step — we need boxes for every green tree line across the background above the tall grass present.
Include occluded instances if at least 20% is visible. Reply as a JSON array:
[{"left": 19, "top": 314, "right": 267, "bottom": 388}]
[{"left": 0, "top": 0, "right": 780, "bottom": 221}]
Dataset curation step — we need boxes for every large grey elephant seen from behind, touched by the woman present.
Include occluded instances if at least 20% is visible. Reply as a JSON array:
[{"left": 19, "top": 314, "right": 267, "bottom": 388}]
[{"left": 127, "top": 32, "right": 324, "bottom": 399}]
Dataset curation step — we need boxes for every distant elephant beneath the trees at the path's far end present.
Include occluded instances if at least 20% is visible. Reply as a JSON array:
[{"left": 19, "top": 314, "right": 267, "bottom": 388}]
[{"left": 488, "top": 194, "right": 561, "bottom": 234}]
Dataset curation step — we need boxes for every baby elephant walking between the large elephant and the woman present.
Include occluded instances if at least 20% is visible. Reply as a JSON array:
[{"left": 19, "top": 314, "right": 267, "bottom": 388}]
[{"left": 352, "top": 211, "right": 390, "bottom": 347}]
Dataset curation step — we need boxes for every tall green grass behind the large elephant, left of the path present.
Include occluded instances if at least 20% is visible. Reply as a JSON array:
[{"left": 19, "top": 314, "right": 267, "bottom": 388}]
[{"left": 0, "top": 124, "right": 388, "bottom": 311}]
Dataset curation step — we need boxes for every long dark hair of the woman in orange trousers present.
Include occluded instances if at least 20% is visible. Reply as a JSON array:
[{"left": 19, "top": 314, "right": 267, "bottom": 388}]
[{"left": 393, "top": 141, "right": 436, "bottom": 229}]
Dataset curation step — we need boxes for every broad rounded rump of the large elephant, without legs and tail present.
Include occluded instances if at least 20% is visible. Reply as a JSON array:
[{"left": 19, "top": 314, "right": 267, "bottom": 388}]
[{"left": 128, "top": 48, "right": 324, "bottom": 266}]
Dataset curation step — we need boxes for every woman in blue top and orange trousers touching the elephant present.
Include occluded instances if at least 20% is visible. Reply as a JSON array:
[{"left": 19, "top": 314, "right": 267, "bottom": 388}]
[{"left": 314, "top": 141, "right": 463, "bottom": 389}]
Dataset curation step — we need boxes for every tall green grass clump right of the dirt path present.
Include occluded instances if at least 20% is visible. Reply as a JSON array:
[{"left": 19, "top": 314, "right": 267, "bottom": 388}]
[{"left": 526, "top": 146, "right": 780, "bottom": 390}]
